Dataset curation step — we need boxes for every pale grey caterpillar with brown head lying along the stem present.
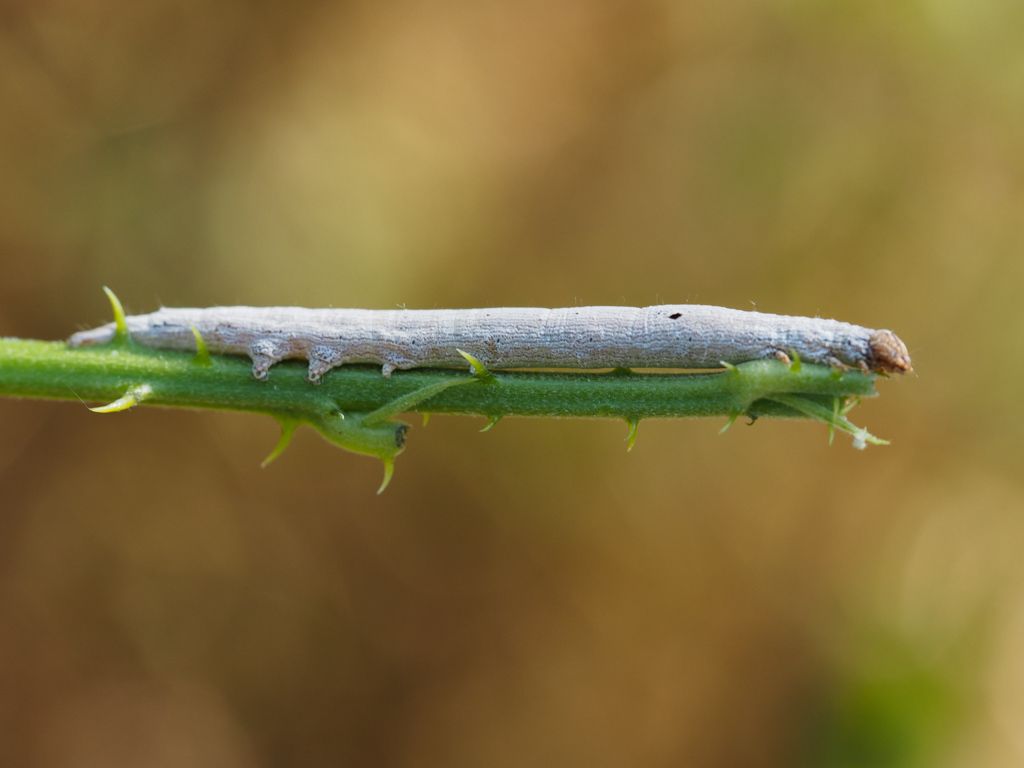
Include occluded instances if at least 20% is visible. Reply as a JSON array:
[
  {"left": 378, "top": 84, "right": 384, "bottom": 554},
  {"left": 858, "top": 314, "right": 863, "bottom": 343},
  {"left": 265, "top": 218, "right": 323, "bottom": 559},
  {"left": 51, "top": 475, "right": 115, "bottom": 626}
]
[{"left": 69, "top": 304, "right": 910, "bottom": 382}]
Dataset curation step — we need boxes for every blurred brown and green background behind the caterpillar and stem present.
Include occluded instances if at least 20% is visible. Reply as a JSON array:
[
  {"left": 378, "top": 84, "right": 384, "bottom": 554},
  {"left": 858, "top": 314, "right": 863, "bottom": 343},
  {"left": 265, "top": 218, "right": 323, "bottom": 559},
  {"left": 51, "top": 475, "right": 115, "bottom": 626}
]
[{"left": 0, "top": 0, "right": 1024, "bottom": 767}]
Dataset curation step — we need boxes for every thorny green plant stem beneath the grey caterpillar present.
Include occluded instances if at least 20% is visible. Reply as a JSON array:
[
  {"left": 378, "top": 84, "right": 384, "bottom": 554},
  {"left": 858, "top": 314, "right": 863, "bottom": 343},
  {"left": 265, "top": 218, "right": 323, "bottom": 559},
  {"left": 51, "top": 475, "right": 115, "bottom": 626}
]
[{"left": 0, "top": 339, "right": 877, "bottom": 489}]
